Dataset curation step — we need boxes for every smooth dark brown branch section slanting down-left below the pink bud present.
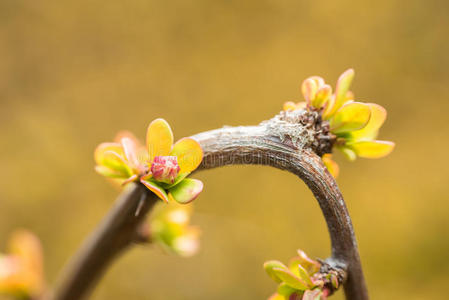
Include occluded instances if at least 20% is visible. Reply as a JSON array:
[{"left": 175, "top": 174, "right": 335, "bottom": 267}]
[{"left": 49, "top": 183, "right": 158, "bottom": 300}]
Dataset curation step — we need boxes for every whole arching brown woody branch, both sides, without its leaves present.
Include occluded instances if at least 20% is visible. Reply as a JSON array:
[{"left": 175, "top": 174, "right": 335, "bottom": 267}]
[{"left": 53, "top": 116, "right": 368, "bottom": 300}]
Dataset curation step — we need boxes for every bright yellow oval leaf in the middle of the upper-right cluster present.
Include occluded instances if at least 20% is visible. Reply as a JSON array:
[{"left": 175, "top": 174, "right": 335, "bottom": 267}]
[{"left": 330, "top": 102, "right": 371, "bottom": 134}]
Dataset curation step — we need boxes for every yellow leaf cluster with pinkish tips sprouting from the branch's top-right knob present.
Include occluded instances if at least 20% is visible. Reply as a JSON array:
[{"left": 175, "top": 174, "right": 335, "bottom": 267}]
[{"left": 284, "top": 69, "right": 394, "bottom": 177}]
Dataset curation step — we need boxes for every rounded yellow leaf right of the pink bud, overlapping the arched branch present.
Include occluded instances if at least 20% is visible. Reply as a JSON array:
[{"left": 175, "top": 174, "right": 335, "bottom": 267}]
[{"left": 170, "top": 138, "right": 203, "bottom": 173}]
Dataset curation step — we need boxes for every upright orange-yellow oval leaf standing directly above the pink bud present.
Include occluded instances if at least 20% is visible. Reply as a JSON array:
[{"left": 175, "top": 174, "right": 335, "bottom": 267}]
[{"left": 147, "top": 119, "right": 173, "bottom": 161}]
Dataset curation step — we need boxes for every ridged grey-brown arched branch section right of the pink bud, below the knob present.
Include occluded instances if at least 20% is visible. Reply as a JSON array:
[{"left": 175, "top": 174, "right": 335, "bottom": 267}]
[{"left": 193, "top": 126, "right": 368, "bottom": 300}]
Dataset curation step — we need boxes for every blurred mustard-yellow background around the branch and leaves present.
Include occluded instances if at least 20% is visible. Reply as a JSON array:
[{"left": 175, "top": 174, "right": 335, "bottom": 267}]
[{"left": 0, "top": 0, "right": 449, "bottom": 300}]
